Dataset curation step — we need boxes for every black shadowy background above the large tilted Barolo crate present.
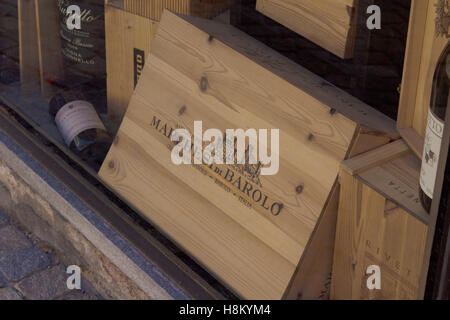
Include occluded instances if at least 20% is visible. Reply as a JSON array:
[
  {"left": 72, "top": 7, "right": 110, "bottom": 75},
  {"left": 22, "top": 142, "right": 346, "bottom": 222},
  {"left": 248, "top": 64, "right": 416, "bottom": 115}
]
[{"left": 231, "top": 0, "right": 411, "bottom": 119}]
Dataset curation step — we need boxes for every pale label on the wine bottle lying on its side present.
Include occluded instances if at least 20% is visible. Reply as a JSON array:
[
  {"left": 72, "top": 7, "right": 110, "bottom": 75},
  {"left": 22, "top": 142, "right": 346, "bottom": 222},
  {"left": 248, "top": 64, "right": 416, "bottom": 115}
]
[{"left": 55, "top": 100, "right": 106, "bottom": 146}]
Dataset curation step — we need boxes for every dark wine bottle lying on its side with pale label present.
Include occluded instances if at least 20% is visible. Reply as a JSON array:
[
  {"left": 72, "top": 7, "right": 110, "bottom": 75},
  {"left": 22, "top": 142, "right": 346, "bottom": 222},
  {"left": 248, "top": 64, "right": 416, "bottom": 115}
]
[{"left": 49, "top": 91, "right": 112, "bottom": 169}]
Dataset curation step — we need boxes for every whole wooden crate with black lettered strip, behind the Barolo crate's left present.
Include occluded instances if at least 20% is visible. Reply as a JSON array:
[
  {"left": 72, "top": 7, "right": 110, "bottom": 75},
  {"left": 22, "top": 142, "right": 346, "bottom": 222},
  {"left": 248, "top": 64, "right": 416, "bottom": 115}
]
[{"left": 105, "top": 0, "right": 229, "bottom": 133}]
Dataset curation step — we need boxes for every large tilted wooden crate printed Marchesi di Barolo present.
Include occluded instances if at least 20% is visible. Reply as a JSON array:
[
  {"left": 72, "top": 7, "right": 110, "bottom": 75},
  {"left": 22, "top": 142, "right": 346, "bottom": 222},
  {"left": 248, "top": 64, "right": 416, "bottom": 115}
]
[{"left": 99, "top": 11, "right": 398, "bottom": 299}]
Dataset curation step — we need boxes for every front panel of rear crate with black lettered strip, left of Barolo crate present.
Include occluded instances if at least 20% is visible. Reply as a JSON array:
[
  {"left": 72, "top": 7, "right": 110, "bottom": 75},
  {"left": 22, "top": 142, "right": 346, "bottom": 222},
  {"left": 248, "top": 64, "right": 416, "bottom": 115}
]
[{"left": 105, "top": 5, "right": 158, "bottom": 133}]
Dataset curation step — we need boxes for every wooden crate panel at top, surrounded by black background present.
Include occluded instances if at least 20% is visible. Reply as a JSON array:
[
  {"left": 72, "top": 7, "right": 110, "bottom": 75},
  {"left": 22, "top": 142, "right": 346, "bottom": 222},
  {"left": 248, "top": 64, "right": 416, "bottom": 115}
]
[{"left": 256, "top": 0, "right": 358, "bottom": 59}]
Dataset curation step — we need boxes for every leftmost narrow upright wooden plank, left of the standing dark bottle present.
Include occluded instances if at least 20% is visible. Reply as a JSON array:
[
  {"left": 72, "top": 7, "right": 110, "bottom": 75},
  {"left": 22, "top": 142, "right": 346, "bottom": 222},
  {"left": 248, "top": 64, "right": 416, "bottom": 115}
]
[{"left": 18, "top": 0, "right": 40, "bottom": 94}]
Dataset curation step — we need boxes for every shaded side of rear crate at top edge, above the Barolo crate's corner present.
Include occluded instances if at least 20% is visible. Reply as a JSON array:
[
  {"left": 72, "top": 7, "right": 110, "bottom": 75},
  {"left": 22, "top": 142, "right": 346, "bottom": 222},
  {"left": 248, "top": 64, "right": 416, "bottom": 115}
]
[{"left": 124, "top": 0, "right": 230, "bottom": 21}]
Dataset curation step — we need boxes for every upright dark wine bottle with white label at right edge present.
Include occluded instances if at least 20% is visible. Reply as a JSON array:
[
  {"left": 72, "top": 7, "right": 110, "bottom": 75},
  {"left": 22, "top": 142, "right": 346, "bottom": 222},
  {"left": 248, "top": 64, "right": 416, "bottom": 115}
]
[{"left": 419, "top": 44, "right": 450, "bottom": 212}]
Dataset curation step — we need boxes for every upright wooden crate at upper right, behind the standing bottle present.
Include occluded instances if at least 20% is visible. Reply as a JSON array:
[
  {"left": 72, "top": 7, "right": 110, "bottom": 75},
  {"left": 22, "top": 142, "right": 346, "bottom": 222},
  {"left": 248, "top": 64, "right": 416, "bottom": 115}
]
[{"left": 397, "top": 0, "right": 449, "bottom": 158}]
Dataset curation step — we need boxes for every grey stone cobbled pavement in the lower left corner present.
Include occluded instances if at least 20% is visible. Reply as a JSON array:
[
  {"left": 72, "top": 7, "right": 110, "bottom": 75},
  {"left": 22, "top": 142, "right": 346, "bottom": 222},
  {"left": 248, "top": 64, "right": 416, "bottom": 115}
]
[{"left": 0, "top": 211, "right": 101, "bottom": 300}]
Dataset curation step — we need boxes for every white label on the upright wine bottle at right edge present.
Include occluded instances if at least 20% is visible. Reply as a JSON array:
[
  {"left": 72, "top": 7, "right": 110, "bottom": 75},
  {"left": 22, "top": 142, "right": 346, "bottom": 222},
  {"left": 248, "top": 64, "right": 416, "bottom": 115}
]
[{"left": 420, "top": 110, "right": 444, "bottom": 199}]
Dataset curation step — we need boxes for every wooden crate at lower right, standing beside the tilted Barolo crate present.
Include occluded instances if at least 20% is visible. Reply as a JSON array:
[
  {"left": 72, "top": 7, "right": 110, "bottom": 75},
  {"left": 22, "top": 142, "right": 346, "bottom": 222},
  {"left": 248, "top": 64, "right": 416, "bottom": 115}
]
[{"left": 331, "top": 140, "right": 429, "bottom": 299}]
